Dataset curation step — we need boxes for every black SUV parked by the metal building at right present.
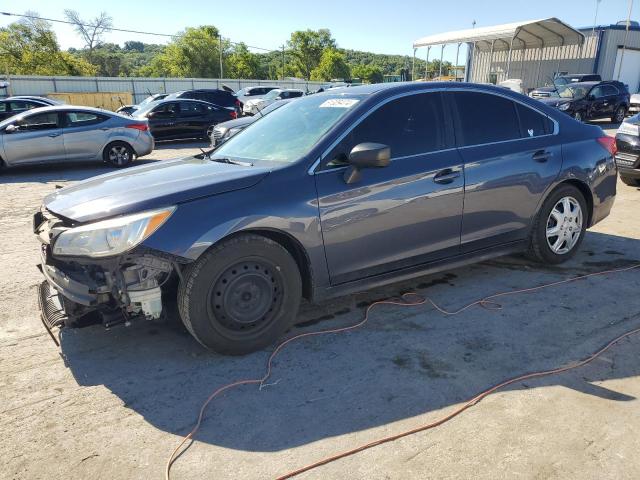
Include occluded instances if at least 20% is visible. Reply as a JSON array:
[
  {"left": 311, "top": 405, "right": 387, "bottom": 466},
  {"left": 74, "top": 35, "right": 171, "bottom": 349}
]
[{"left": 538, "top": 81, "right": 630, "bottom": 123}]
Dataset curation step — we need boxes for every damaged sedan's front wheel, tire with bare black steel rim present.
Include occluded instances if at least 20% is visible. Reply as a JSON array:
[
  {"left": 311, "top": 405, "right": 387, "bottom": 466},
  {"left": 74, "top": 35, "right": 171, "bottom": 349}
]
[{"left": 178, "top": 234, "right": 302, "bottom": 355}]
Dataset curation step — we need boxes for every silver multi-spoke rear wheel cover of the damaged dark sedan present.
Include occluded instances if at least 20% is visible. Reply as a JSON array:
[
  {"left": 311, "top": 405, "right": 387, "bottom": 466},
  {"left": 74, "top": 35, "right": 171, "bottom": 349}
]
[{"left": 546, "top": 196, "right": 583, "bottom": 255}]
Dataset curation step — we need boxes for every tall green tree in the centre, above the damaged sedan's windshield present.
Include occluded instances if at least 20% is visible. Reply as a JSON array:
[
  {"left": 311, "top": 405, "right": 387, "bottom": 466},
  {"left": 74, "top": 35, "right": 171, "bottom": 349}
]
[{"left": 287, "top": 28, "right": 336, "bottom": 80}]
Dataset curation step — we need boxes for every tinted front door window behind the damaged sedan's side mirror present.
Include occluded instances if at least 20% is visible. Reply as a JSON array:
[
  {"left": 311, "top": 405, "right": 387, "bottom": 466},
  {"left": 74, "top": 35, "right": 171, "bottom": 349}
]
[{"left": 326, "top": 93, "right": 447, "bottom": 167}]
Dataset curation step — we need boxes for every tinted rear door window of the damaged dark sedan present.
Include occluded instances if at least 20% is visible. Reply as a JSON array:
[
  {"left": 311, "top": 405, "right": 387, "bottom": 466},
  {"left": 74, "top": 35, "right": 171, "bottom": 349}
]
[{"left": 453, "top": 92, "right": 520, "bottom": 146}]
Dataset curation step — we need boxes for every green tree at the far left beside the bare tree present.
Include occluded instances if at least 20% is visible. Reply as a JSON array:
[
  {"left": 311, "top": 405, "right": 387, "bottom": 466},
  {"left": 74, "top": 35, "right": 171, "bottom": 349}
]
[{"left": 0, "top": 12, "right": 96, "bottom": 75}]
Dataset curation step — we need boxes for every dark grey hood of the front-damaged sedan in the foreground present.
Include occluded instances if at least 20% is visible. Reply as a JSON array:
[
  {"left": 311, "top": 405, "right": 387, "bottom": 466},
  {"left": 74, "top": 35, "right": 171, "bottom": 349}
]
[{"left": 44, "top": 157, "right": 270, "bottom": 223}]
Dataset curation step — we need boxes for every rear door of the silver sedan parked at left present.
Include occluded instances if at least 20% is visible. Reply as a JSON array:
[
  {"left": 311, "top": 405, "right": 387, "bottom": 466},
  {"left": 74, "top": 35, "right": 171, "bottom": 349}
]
[{"left": 62, "top": 110, "right": 109, "bottom": 160}]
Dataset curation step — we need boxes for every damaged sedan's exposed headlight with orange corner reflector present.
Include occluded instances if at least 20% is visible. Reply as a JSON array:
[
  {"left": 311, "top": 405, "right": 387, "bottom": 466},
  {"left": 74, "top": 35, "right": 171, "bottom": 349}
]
[{"left": 53, "top": 207, "right": 176, "bottom": 257}]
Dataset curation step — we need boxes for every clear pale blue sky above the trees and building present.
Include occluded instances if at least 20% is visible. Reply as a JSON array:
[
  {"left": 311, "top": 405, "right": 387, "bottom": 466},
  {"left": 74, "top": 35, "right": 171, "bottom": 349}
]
[{"left": 0, "top": 0, "right": 640, "bottom": 63}]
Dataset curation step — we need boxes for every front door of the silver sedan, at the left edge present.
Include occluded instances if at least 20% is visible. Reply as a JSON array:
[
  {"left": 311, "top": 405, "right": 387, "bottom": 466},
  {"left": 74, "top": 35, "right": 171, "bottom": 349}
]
[{"left": 2, "top": 112, "right": 65, "bottom": 165}]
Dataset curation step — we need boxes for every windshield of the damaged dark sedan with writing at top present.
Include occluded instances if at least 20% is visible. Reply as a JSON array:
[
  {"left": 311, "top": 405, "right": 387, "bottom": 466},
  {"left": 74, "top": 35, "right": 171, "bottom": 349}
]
[{"left": 214, "top": 95, "right": 360, "bottom": 163}]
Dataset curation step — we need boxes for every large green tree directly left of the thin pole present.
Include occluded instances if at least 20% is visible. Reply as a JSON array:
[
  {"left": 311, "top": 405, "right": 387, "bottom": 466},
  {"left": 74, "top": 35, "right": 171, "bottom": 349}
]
[{"left": 139, "top": 25, "right": 224, "bottom": 78}]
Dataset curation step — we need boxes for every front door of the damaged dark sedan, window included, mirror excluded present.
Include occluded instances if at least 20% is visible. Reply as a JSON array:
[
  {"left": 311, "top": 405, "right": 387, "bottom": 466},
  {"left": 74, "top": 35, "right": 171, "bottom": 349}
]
[{"left": 315, "top": 92, "right": 464, "bottom": 285}]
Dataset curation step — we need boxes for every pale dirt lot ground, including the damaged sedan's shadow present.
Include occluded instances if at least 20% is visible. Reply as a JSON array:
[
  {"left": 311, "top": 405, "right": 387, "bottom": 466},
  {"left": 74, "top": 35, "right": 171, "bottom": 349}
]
[{"left": 0, "top": 133, "right": 640, "bottom": 480}]
